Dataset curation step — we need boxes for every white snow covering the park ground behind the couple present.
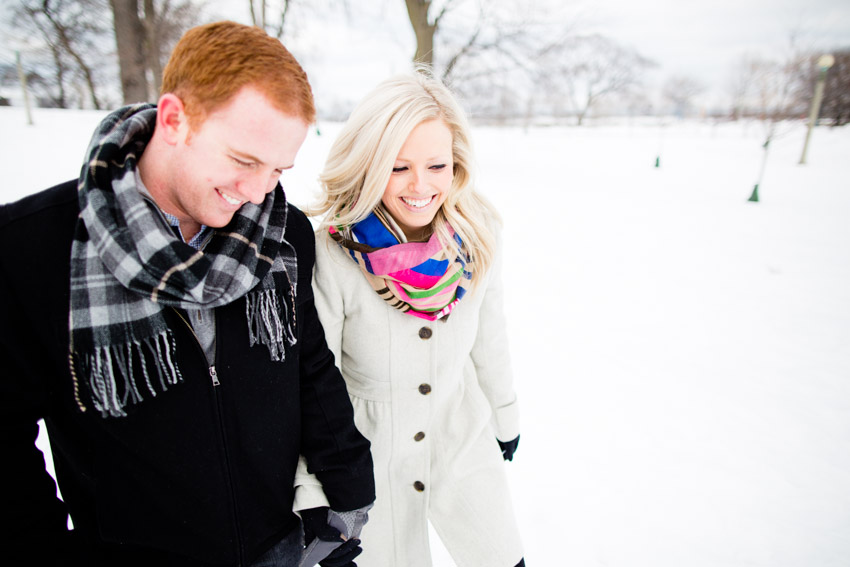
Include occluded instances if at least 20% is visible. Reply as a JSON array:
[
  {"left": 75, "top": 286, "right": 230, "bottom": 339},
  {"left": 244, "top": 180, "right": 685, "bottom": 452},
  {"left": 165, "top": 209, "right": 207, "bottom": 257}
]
[{"left": 0, "top": 108, "right": 850, "bottom": 567}]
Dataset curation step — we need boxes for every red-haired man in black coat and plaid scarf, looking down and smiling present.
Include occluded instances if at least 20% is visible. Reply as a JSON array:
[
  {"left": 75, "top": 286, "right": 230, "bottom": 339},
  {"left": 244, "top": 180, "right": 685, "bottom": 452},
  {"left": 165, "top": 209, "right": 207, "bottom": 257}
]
[{"left": 0, "top": 22, "right": 375, "bottom": 566}]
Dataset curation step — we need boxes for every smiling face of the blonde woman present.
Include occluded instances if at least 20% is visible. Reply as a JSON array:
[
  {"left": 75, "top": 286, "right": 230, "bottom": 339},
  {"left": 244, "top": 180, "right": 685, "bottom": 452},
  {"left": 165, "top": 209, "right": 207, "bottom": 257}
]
[{"left": 381, "top": 119, "right": 454, "bottom": 241}]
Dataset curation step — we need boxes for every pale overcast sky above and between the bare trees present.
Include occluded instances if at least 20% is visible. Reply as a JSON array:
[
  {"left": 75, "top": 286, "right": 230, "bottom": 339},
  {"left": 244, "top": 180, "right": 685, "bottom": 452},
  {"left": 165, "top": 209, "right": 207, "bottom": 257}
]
[{"left": 211, "top": 0, "right": 850, "bottom": 112}]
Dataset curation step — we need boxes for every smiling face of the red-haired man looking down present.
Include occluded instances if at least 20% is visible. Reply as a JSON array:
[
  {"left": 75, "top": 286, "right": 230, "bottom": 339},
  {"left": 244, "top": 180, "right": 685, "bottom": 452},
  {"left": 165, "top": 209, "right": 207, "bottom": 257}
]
[{"left": 162, "top": 87, "right": 309, "bottom": 233}]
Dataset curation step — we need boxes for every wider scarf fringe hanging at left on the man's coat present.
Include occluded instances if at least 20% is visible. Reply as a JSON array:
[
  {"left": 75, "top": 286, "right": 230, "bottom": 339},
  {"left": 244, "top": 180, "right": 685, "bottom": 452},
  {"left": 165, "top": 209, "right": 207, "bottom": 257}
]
[{"left": 75, "top": 330, "right": 183, "bottom": 417}]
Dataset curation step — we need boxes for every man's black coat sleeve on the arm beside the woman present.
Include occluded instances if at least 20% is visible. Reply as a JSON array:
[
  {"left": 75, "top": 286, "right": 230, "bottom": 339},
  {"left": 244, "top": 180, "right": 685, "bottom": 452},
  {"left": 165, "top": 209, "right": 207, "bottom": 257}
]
[{"left": 287, "top": 210, "right": 375, "bottom": 512}]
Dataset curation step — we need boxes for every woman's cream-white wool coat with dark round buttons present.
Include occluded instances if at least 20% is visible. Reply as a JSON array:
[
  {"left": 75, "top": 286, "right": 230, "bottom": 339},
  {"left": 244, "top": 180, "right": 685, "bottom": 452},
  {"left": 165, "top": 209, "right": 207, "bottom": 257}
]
[{"left": 302, "top": 232, "right": 523, "bottom": 567}]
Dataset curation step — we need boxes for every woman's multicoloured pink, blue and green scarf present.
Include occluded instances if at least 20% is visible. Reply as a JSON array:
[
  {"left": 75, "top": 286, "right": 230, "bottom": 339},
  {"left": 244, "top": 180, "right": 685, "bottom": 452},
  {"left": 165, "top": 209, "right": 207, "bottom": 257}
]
[{"left": 328, "top": 206, "right": 472, "bottom": 321}]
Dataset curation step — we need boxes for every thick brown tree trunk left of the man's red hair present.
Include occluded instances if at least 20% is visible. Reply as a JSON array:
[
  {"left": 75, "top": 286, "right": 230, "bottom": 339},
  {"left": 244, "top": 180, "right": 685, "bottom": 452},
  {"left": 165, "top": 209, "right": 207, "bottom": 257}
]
[{"left": 109, "top": 0, "right": 148, "bottom": 104}]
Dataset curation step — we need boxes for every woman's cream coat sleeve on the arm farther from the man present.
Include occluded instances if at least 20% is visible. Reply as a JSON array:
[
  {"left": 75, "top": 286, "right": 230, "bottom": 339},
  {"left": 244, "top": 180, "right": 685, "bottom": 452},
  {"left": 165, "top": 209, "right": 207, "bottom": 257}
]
[{"left": 472, "top": 233, "right": 519, "bottom": 441}]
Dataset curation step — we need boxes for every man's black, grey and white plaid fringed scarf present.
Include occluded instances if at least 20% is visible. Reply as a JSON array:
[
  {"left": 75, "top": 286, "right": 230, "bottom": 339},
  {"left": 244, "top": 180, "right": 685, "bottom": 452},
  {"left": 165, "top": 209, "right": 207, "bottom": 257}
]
[{"left": 69, "top": 104, "right": 297, "bottom": 417}]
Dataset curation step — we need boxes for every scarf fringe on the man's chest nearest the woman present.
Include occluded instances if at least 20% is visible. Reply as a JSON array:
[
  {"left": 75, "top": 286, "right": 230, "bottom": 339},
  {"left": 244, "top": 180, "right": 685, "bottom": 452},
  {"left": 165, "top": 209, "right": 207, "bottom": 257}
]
[{"left": 245, "top": 289, "right": 295, "bottom": 362}]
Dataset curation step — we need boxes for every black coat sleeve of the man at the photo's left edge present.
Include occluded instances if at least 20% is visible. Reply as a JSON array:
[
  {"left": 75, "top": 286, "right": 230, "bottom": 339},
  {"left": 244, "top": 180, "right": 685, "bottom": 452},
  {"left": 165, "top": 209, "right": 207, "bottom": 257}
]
[{"left": 0, "top": 187, "right": 81, "bottom": 564}]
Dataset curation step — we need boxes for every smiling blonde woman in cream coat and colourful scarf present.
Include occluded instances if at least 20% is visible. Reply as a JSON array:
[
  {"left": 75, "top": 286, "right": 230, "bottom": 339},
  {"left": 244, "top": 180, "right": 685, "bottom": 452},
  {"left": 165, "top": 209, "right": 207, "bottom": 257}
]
[{"left": 313, "top": 73, "right": 524, "bottom": 567}]
